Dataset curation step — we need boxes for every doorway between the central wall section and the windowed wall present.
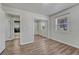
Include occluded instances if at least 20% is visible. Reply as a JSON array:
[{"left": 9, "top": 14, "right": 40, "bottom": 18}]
[{"left": 34, "top": 20, "right": 48, "bottom": 37}]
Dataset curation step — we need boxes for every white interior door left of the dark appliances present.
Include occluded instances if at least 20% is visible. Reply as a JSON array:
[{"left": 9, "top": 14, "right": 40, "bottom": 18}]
[{"left": 6, "top": 14, "right": 14, "bottom": 40}]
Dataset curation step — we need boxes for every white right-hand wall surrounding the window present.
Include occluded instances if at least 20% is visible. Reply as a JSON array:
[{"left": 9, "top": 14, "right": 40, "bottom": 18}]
[{"left": 49, "top": 5, "right": 79, "bottom": 48}]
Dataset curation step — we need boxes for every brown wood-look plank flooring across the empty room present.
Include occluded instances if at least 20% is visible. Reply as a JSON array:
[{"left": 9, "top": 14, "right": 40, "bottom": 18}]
[{"left": 2, "top": 36, "right": 79, "bottom": 55}]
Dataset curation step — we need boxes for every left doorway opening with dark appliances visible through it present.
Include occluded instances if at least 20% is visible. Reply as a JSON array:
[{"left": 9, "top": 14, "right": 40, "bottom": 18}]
[{"left": 7, "top": 14, "right": 20, "bottom": 40}]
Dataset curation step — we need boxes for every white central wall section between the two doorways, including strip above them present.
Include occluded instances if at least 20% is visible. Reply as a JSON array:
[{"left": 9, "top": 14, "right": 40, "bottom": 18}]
[{"left": 3, "top": 6, "right": 48, "bottom": 44}]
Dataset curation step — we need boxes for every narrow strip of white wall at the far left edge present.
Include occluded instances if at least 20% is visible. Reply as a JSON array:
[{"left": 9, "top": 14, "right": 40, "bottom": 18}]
[{"left": 0, "top": 4, "right": 6, "bottom": 53}]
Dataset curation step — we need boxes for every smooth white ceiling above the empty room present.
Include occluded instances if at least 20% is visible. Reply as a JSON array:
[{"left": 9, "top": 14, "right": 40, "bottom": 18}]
[{"left": 3, "top": 3, "right": 75, "bottom": 15}]
